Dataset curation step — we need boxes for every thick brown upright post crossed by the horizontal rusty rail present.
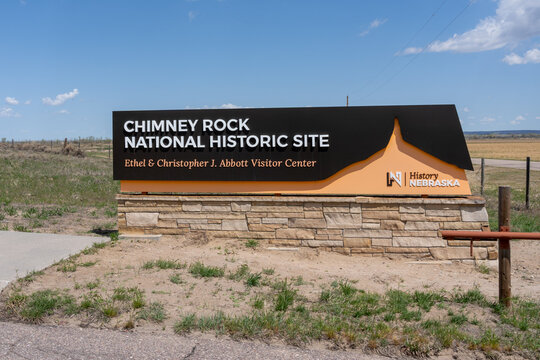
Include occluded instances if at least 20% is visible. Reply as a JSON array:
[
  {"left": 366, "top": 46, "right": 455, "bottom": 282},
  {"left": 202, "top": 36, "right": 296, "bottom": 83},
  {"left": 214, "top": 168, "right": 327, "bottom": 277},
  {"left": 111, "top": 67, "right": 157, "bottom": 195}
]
[{"left": 499, "top": 186, "right": 512, "bottom": 308}]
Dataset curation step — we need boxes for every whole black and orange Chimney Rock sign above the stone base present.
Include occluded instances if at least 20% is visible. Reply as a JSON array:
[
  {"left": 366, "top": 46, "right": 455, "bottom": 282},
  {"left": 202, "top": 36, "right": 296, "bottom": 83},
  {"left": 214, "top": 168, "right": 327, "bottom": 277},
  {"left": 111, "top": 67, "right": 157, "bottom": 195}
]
[{"left": 113, "top": 105, "right": 472, "bottom": 195}]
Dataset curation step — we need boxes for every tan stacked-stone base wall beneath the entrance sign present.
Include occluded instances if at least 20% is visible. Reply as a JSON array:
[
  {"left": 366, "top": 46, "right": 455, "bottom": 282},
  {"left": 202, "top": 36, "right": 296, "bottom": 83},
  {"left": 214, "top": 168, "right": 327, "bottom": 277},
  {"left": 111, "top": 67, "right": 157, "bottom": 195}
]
[{"left": 117, "top": 194, "right": 497, "bottom": 259}]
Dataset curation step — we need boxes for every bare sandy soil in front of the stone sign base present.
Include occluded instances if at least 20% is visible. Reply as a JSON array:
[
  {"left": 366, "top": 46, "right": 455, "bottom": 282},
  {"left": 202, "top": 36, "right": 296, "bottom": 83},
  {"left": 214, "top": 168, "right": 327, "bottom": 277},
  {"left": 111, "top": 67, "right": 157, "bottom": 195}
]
[{"left": 2, "top": 235, "right": 540, "bottom": 359}]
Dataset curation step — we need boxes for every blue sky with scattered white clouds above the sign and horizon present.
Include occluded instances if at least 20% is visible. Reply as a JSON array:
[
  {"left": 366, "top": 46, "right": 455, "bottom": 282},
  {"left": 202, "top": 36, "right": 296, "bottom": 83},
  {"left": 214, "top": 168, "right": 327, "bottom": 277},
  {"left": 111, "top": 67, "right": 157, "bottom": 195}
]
[{"left": 0, "top": 0, "right": 540, "bottom": 139}]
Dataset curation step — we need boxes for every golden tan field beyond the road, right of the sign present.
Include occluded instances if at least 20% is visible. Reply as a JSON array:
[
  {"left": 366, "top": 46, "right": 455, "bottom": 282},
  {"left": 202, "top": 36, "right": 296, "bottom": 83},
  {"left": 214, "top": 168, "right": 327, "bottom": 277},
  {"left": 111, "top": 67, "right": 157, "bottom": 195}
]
[{"left": 467, "top": 138, "right": 540, "bottom": 161}]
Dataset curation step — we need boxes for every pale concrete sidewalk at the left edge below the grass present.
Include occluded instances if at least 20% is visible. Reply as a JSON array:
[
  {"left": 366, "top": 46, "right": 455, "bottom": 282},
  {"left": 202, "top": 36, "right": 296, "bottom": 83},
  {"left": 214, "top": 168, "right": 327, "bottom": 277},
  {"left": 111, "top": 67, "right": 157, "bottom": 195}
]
[{"left": 0, "top": 231, "right": 105, "bottom": 290}]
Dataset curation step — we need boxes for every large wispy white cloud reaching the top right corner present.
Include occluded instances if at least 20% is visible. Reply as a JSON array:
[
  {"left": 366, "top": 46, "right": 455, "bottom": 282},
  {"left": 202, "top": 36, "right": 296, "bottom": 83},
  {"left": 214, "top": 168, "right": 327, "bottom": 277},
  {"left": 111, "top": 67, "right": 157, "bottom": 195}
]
[{"left": 428, "top": 0, "right": 540, "bottom": 52}]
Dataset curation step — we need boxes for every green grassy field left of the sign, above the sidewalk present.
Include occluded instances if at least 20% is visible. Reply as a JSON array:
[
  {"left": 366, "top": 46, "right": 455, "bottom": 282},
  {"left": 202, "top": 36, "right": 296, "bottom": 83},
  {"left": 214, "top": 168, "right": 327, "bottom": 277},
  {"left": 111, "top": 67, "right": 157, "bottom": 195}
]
[{"left": 0, "top": 142, "right": 119, "bottom": 234}]
